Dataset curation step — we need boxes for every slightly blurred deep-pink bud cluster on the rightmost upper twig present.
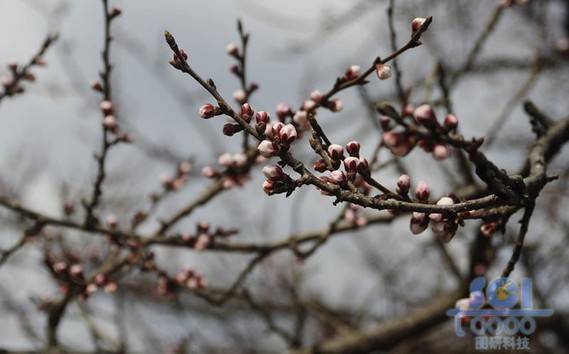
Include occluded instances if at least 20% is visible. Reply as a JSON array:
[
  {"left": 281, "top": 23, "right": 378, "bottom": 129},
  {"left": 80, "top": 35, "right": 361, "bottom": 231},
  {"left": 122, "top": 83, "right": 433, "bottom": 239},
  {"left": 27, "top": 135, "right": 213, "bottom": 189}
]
[{"left": 377, "top": 105, "right": 458, "bottom": 160}]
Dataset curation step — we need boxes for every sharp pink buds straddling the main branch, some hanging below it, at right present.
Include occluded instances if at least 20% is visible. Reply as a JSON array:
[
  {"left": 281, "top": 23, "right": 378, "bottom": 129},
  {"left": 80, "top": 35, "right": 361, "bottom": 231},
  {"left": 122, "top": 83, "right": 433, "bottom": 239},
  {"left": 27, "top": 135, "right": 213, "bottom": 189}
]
[{"left": 406, "top": 180, "right": 458, "bottom": 242}]
